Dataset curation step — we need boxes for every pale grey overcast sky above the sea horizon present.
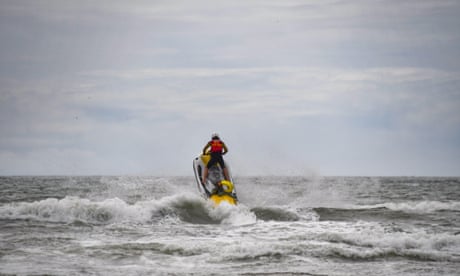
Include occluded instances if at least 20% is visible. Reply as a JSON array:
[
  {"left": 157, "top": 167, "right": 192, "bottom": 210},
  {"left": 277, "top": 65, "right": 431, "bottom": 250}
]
[{"left": 0, "top": 0, "right": 460, "bottom": 176}]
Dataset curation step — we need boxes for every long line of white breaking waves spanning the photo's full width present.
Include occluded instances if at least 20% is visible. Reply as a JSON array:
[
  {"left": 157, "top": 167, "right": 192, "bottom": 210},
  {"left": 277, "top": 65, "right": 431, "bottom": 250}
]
[{"left": 0, "top": 194, "right": 460, "bottom": 225}]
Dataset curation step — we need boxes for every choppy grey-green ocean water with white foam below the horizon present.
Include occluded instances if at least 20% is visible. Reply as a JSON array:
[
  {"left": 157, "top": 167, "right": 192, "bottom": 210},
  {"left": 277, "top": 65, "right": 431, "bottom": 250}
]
[{"left": 0, "top": 176, "right": 460, "bottom": 275}]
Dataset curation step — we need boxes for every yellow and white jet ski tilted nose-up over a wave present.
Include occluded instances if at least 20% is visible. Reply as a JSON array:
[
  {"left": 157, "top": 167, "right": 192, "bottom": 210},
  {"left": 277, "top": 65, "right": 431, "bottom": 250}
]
[{"left": 193, "top": 154, "right": 238, "bottom": 206}]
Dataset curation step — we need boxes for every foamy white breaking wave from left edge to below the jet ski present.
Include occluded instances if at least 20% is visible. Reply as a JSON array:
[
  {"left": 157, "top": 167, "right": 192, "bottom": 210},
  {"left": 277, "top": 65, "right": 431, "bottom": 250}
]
[{"left": 0, "top": 195, "right": 257, "bottom": 225}]
